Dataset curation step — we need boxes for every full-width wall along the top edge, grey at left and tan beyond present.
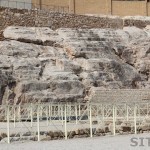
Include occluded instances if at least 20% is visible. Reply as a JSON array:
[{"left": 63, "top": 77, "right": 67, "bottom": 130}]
[{"left": 0, "top": 0, "right": 150, "bottom": 16}]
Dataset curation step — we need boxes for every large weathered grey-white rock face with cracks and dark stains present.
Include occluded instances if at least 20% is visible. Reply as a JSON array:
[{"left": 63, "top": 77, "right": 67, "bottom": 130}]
[{"left": 0, "top": 26, "right": 150, "bottom": 104}]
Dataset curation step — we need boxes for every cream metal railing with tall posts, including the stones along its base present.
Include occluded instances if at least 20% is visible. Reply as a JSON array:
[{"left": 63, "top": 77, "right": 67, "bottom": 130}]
[{"left": 0, "top": 103, "right": 150, "bottom": 143}]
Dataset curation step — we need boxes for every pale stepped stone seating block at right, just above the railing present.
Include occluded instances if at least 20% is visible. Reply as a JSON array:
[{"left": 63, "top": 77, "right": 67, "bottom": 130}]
[{"left": 89, "top": 87, "right": 150, "bottom": 103}]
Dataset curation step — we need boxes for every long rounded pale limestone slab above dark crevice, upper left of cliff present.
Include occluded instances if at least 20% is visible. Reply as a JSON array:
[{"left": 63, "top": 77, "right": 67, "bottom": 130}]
[{"left": 4, "top": 26, "right": 62, "bottom": 46}]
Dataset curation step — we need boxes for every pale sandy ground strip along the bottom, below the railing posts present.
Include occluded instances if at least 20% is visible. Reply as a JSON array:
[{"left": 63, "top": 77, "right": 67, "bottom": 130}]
[{"left": 0, "top": 133, "right": 150, "bottom": 150}]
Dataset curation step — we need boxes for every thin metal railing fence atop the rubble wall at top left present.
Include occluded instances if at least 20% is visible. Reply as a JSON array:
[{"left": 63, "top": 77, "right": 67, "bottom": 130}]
[{"left": 0, "top": 0, "right": 69, "bottom": 13}]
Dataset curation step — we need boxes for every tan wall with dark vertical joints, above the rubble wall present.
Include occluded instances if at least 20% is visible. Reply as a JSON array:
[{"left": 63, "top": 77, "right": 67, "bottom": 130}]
[{"left": 32, "top": 0, "right": 150, "bottom": 16}]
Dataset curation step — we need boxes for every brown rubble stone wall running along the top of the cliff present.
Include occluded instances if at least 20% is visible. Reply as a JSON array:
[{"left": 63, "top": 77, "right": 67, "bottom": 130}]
[{"left": 0, "top": 7, "right": 150, "bottom": 40}]
